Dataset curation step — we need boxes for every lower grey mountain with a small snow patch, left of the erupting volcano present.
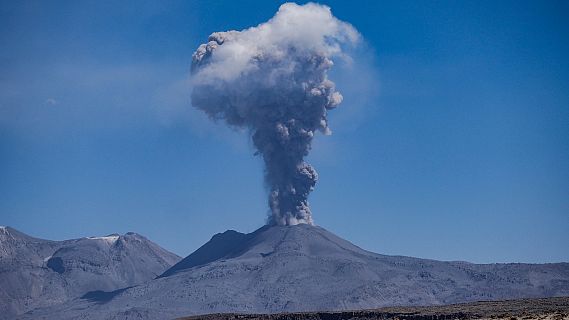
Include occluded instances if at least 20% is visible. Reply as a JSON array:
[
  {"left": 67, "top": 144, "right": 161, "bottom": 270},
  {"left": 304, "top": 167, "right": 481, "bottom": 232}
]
[{"left": 0, "top": 227, "right": 180, "bottom": 319}]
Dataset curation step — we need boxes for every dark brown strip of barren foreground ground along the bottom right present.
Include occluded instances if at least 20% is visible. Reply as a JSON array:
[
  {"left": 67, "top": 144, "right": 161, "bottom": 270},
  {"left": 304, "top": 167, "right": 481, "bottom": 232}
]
[{"left": 182, "top": 297, "right": 569, "bottom": 320}]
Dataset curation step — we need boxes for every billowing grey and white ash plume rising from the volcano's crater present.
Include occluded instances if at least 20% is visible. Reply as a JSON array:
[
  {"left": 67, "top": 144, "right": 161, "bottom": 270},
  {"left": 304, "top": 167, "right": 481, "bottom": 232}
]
[{"left": 192, "top": 3, "right": 359, "bottom": 225}]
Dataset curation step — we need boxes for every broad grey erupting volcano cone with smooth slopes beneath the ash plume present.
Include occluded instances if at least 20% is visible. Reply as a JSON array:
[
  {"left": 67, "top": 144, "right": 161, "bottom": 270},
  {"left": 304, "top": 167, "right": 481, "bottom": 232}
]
[{"left": 18, "top": 225, "right": 569, "bottom": 319}]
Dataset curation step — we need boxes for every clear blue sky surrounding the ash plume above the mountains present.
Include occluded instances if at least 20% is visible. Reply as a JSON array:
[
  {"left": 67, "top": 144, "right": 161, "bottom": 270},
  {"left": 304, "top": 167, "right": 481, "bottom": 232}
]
[{"left": 0, "top": 1, "right": 569, "bottom": 262}]
